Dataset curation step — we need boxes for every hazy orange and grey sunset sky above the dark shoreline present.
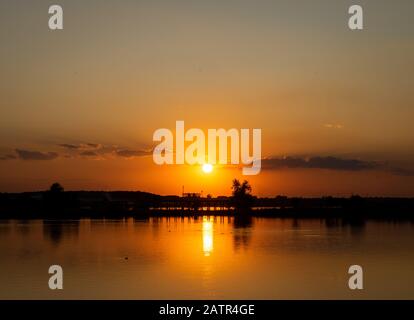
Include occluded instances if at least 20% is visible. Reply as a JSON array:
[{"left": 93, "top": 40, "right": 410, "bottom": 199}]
[{"left": 0, "top": 0, "right": 414, "bottom": 196}]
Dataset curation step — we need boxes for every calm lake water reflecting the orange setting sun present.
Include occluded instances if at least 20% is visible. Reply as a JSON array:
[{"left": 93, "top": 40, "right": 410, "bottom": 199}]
[{"left": 0, "top": 217, "right": 414, "bottom": 299}]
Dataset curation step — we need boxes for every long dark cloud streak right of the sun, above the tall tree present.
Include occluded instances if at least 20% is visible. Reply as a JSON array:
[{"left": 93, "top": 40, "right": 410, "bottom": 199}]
[{"left": 262, "top": 157, "right": 380, "bottom": 171}]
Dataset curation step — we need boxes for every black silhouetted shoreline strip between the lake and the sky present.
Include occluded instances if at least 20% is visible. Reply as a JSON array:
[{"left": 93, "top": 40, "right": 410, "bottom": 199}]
[{"left": 0, "top": 190, "right": 414, "bottom": 221}]
